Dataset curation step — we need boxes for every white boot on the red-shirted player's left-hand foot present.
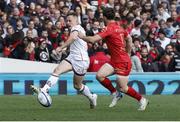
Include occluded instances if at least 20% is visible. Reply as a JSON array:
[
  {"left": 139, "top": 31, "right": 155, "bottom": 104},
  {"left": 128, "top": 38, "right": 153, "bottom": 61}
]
[{"left": 109, "top": 91, "right": 123, "bottom": 108}]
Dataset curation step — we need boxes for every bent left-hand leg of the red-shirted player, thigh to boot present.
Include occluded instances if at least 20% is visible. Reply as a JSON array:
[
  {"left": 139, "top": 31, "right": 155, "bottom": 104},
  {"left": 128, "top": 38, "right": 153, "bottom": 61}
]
[{"left": 96, "top": 63, "right": 122, "bottom": 107}]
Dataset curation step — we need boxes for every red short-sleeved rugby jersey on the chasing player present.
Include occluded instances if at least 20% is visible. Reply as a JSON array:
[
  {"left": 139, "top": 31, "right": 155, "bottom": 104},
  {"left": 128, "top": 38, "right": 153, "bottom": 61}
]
[{"left": 98, "top": 22, "right": 130, "bottom": 63}]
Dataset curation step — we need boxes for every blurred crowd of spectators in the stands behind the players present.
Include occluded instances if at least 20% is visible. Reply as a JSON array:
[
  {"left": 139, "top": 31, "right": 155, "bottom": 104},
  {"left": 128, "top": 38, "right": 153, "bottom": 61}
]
[{"left": 0, "top": 0, "right": 180, "bottom": 72}]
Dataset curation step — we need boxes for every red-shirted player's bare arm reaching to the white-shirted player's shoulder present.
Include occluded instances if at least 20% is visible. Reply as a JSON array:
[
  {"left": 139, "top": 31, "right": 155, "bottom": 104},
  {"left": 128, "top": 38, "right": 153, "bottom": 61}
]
[{"left": 78, "top": 32, "right": 102, "bottom": 43}]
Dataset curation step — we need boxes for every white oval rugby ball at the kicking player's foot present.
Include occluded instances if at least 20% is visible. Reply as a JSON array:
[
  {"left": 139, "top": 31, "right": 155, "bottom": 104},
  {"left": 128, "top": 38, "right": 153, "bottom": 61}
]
[{"left": 37, "top": 92, "right": 52, "bottom": 107}]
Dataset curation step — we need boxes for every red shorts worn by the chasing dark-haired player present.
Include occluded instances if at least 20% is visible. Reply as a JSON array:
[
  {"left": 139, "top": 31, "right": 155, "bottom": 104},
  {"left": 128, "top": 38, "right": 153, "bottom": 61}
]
[{"left": 109, "top": 60, "right": 132, "bottom": 76}]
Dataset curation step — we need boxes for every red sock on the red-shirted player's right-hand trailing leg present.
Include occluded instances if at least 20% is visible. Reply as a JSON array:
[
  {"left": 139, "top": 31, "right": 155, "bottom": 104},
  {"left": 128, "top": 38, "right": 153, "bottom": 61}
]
[{"left": 126, "top": 87, "right": 142, "bottom": 101}]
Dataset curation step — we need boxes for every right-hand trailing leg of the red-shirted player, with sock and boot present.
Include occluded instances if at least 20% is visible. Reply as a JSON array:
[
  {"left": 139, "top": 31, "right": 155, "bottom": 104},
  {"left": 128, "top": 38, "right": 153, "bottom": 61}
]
[{"left": 117, "top": 75, "right": 149, "bottom": 111}]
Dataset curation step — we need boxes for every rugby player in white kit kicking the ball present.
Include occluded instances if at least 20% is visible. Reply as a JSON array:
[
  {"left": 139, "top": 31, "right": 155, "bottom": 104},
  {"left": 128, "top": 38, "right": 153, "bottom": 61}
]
[{"left": 31, "top": 13, "right": 97, "bottom": 108}]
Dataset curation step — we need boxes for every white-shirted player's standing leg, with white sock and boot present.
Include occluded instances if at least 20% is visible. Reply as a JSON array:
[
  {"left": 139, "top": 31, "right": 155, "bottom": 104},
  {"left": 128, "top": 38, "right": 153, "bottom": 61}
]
[{"left": 73, "top": 74, "right": 97, "bottom": 109}]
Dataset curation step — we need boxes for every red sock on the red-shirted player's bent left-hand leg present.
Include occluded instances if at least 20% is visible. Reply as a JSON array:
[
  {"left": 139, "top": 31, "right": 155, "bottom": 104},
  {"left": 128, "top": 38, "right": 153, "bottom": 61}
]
[{"left": 100, "top": 78, "right": 116, "bottom": 93}]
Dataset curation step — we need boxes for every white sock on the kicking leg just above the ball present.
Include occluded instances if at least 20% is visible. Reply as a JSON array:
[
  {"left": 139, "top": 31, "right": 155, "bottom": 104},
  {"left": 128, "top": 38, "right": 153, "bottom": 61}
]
[{"left": 41, "top": 75, "right": 59, "bottom": 92}]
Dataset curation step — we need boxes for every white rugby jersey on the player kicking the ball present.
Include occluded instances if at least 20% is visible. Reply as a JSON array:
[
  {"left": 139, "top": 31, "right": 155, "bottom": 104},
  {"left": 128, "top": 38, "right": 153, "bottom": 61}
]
[{"left": 70, "top": 25, "right": 89, "bottom": 60}]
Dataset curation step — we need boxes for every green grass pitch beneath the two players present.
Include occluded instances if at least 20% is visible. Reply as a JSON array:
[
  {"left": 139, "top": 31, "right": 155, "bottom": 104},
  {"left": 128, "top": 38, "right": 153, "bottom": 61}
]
[{"left": 0, "top": 95, "right": 180, "bottom": 121}]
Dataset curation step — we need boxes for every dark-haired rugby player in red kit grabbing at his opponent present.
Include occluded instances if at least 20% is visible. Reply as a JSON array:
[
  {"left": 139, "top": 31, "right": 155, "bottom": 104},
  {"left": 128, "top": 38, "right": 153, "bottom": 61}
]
[{"left": 79, "top": 8, "right": 148, "bottom": 111}]
